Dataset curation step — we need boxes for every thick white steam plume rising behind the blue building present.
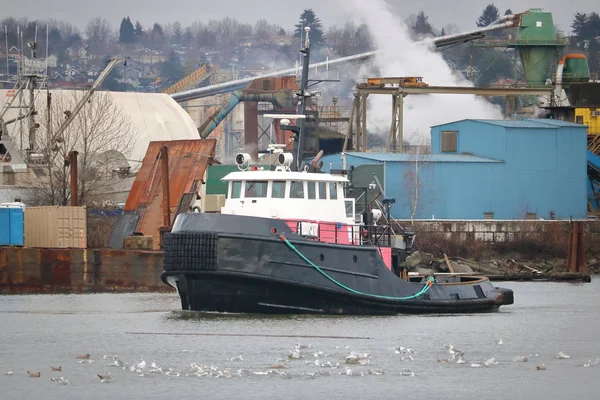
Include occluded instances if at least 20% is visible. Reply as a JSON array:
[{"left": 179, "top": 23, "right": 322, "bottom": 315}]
[{"left": 344, "top": 0, "right": 502, "bottom": 142}]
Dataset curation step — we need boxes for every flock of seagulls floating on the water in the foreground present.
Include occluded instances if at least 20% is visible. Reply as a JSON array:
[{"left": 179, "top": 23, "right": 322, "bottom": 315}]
[{"left": 6, "top": 339, "right": 600, "bottom": 385}]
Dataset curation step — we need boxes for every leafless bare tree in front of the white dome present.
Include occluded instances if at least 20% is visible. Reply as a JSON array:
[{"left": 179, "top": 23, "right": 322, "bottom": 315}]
[{"left": 30, "top": 91, "right": 135, "bottom": 205}]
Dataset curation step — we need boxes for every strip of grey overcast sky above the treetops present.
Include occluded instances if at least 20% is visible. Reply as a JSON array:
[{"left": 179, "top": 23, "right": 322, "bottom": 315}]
[{"left": 2, "top": 0, "right": 600, "bottom": 32}]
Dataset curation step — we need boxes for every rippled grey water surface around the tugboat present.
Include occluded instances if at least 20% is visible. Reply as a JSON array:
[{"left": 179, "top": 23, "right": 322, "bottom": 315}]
[{"left": 0, "top": 279, "right": 600, "bottom": 400}]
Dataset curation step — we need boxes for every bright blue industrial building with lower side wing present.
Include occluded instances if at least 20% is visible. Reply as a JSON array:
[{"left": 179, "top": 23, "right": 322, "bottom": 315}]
[{"left": 322, "top": 119, "right": 587, "bottom": 219}]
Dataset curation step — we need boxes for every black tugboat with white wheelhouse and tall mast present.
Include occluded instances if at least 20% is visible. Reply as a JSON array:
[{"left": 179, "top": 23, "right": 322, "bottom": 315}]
[{"left": 161, "top": 28, "right": 513, "bottom": 315}]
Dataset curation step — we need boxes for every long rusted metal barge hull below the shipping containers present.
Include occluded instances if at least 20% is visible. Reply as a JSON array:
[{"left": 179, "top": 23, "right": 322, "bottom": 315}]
[{"left": 0, "top": 247, "right": 173, "bottom": 294}]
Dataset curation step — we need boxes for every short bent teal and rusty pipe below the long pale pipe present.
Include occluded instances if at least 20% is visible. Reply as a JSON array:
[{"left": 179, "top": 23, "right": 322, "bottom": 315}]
[{"left": 198, "top": 90, "right": 293, "bottom": 139}]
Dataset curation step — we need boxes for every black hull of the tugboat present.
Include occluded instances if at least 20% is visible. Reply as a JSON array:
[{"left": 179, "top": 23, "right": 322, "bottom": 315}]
[{"left": 162, "top": 214, "right": 513, "bottom": 315}]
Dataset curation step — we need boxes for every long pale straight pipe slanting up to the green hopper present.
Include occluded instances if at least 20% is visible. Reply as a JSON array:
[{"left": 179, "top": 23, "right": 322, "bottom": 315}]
[{"left": 171, "top": 19, "right": 520, "bottom": 102}]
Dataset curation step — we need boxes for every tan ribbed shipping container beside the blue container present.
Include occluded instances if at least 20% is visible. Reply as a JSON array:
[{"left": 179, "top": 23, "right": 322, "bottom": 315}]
[{"left": 25, "top": 206, "right": 87, "bottom": 248}]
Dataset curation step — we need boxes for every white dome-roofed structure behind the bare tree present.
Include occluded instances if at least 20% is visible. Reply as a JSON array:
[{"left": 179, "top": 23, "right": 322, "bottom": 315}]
[{"left": 0, "top": 89, "right": 200, "bottom": 169}]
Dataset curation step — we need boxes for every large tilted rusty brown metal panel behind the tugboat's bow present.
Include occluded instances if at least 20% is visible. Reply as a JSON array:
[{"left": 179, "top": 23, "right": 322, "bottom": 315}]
[{"left": 125, "top": 139, "right": 216, "bottom": 249}]
